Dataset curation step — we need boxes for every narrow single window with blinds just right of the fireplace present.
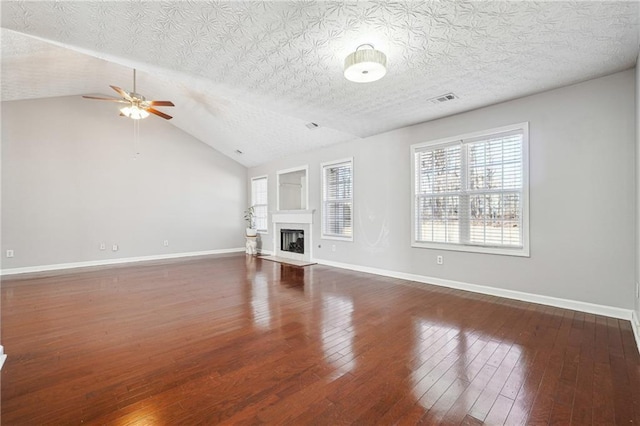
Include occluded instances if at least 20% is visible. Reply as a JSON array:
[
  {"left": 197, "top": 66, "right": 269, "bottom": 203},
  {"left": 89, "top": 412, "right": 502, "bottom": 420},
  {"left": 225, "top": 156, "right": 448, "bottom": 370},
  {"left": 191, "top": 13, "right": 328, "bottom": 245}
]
[{"left": 322, "top": 159, "right": 353, "bottom": 241}]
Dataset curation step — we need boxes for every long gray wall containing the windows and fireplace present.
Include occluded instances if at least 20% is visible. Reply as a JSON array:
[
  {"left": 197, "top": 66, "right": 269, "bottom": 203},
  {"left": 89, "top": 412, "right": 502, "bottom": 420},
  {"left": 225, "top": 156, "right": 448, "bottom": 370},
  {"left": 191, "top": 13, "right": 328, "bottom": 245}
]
[{"left": 248, "top": 70, "right": 636, "bottom": 309}]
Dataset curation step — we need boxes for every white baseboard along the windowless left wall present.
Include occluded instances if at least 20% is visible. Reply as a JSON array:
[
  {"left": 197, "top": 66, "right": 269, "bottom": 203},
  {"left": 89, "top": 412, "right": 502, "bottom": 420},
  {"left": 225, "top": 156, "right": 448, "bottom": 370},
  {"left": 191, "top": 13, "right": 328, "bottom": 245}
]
[{"left": 0, "top": 247, "right": 245, "bottom": 276}]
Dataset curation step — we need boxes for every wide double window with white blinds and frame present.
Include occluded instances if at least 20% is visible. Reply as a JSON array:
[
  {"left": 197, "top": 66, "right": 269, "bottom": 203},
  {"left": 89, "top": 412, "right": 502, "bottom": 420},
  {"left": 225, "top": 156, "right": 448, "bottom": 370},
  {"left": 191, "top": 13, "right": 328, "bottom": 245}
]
[{"left": 411, "top": 123, "right": 529, "bottom": 256}]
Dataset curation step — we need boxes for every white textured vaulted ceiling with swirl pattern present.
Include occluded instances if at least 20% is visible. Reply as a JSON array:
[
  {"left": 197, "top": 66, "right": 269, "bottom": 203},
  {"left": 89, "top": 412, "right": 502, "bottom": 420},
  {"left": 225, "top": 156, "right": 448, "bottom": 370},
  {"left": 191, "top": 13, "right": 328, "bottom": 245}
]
[{"left": 1, "top": 0, "right": 638, "bottom": 166}]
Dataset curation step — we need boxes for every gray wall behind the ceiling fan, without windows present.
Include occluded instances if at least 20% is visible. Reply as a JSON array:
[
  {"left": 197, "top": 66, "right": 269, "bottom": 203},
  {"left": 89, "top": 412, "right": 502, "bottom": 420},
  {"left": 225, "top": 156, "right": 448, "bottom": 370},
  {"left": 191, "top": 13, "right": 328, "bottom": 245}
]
[{"left": 2, "top": 96, "right": 247, "bottom": 269}]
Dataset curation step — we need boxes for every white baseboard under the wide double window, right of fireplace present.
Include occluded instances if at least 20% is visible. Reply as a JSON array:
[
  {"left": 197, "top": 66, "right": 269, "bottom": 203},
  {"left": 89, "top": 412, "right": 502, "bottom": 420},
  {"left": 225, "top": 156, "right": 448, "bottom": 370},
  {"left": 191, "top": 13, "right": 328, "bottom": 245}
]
[{"left": 313, "top": 259, "right": 638, "bottom": 320}]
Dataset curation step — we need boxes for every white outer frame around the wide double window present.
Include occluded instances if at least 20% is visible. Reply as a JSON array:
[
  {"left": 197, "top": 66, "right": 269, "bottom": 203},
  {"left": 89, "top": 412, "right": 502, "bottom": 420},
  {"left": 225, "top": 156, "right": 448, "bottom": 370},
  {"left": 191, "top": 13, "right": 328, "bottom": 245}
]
[{"left": 410, "top": 122, "right": 530, "bottom": 257}]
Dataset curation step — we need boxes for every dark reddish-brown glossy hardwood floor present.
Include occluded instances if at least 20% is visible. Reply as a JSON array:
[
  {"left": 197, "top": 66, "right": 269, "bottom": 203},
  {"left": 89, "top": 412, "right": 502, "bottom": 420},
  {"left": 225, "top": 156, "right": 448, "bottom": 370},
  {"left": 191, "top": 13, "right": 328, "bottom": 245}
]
[{"left": 2, "top": 255, "right": 640, "bottom": 425}]
